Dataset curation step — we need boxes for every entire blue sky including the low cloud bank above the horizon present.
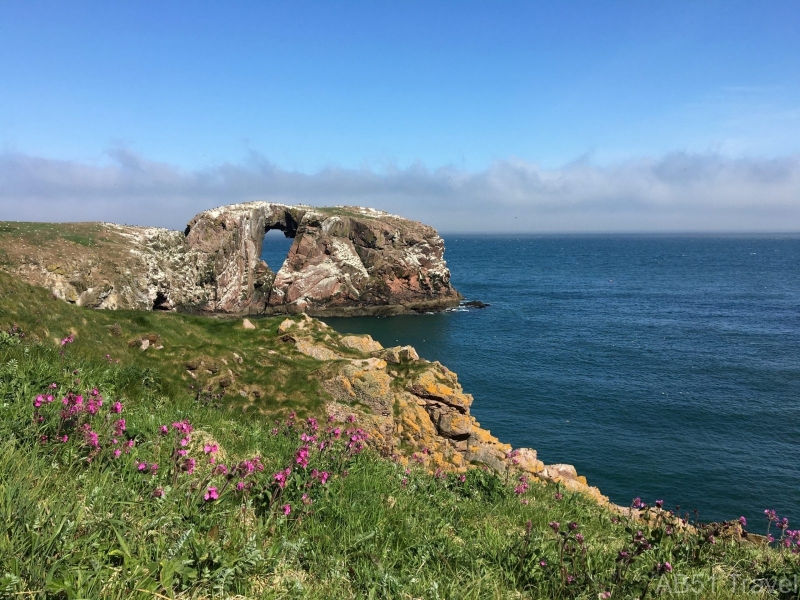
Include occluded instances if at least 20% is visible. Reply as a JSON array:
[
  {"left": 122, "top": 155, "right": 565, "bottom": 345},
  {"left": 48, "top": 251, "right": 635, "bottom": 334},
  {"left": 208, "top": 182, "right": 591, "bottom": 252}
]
[{"left": 0, "top": 0, "right": 800, "bottom": 233}]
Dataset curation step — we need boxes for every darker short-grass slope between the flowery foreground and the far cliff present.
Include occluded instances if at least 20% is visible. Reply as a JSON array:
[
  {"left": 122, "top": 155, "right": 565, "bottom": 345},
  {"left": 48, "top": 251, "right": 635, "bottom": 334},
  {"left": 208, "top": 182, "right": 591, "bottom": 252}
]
[{"left": 0, "top": 273, "right": 325, "bottom": 415}]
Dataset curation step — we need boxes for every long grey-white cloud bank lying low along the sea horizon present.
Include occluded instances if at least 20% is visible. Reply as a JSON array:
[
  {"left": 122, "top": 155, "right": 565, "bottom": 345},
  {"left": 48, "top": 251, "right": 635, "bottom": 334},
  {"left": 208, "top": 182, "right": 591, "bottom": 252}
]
[{"left": 0, "top": 148, "right": 800, "bottom": 233}]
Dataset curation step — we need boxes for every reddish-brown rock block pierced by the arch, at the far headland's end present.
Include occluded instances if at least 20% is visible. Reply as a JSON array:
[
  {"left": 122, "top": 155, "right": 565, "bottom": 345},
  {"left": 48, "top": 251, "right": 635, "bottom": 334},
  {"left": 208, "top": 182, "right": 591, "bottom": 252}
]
[{"left": 186, "top": 202, "right": 460, "bottom": 315}]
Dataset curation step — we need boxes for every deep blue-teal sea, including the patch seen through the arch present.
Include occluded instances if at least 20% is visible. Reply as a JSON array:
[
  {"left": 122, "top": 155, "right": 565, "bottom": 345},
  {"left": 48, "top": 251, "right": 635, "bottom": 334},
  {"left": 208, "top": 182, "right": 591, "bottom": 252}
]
[{"left": 265, "top": 235, "right": 800, "bottom": 529}]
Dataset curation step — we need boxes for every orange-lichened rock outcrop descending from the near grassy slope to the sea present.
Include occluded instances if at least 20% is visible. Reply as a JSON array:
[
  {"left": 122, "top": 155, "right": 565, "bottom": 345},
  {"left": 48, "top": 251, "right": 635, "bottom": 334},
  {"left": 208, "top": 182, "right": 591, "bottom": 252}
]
[{"left": 279, "top": 315, "right": 608, "bottom": 504}]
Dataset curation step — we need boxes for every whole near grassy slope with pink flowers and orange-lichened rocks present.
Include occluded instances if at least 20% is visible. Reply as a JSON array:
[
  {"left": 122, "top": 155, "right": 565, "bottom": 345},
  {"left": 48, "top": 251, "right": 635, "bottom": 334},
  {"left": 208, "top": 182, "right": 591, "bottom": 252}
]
[{"left": 0, "top": 273, "right": 800, "bottom": 599}]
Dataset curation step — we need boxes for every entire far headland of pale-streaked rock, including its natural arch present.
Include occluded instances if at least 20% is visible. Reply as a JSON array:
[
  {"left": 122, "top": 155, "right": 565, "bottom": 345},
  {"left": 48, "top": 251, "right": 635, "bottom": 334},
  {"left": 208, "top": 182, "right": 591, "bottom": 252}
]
[{"left": 0, "top": 202, "right": 460, "bottom": 315}]
